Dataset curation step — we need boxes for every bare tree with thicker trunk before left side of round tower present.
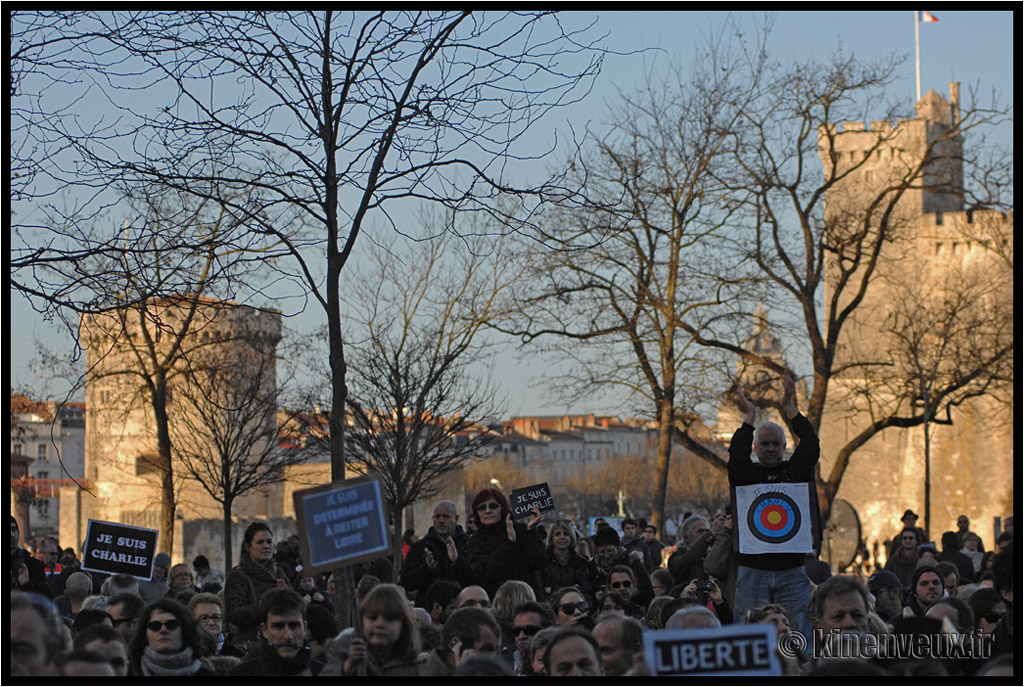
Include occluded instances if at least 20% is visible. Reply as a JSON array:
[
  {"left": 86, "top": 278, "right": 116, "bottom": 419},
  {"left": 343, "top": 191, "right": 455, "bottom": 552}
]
[{"left": 76, "top": 189, "right": 268, "bottom": 551}]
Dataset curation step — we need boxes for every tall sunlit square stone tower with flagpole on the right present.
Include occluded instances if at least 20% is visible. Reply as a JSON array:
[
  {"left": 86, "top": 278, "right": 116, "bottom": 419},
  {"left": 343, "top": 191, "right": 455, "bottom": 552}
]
[{"left": 820, "top": 84, "right": 1014, "bottom": 551}]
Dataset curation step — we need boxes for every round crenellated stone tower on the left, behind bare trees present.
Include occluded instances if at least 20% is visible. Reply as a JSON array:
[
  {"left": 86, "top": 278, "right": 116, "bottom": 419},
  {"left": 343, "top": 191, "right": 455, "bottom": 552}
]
[{"left": 71, "top": 295, "right": 282, "bottom": 560}]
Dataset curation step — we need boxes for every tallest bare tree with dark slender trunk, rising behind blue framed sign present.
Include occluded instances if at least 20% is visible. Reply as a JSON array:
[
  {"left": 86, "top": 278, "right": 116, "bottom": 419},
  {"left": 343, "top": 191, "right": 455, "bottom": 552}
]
[{"left": 12, "top": 11, "right": 601, "bottom": 624}]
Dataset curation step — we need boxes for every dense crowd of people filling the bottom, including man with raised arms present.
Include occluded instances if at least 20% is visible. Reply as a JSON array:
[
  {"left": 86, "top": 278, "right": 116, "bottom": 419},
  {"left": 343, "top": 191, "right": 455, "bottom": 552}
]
[{"left": 8, "top": 379, "right": 1014, "bottom": 679}]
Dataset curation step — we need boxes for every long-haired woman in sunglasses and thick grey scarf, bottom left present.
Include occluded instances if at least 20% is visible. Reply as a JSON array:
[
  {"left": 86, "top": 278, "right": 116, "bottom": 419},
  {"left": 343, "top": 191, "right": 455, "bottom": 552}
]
[{"left": 129, "top": 598, "right": 215, "bottom": 677}]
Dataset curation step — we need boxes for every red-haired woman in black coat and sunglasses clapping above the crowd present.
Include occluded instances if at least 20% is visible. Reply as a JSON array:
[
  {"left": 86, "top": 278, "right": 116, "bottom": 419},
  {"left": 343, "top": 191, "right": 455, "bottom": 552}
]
[{"left": 468, "top": 488, "right": 544, "bottom": 599}]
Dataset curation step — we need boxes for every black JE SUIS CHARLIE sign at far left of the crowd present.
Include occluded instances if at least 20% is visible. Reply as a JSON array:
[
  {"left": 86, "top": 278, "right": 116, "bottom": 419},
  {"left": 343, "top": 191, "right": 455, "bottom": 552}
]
[{"left": 82, "top": 520, "right": 159, "bottom": 579}]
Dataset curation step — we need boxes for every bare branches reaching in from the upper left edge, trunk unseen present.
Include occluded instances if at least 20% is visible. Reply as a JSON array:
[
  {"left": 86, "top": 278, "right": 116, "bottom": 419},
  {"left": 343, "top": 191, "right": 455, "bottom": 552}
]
[{"left": 9, "top": 11, "right": 273, "bottom": 333}]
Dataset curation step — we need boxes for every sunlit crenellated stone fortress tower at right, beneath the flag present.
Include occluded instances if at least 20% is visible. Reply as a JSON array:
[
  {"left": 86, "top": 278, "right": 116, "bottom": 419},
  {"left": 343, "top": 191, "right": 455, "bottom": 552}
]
[{"left": 819, "top": 84, "right": 1014, "bottom": 547}]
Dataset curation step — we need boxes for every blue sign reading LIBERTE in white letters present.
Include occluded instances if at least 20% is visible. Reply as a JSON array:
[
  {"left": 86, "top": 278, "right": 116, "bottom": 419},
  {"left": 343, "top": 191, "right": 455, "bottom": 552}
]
[{"left": 643, "top": 625, "right": 782, "bottom": 676}]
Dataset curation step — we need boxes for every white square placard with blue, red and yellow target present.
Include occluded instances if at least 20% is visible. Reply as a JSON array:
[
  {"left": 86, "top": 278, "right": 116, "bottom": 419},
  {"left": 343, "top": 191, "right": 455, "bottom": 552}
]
[{"left": 734, "top": 482, "right": 814, "bottom": 554}]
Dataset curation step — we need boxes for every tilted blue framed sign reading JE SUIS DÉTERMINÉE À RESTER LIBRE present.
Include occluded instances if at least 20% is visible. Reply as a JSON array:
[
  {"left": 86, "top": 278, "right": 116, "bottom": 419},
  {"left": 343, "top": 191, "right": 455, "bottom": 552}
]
[{"left": 294, "top": 477, "right": 391, "bottom": 572}]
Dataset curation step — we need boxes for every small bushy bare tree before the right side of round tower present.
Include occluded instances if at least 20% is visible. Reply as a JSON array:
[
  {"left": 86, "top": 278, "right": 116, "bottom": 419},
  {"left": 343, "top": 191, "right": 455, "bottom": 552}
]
[{"left": 171, "top": 331, "right": 306, "bottom": 568}]
